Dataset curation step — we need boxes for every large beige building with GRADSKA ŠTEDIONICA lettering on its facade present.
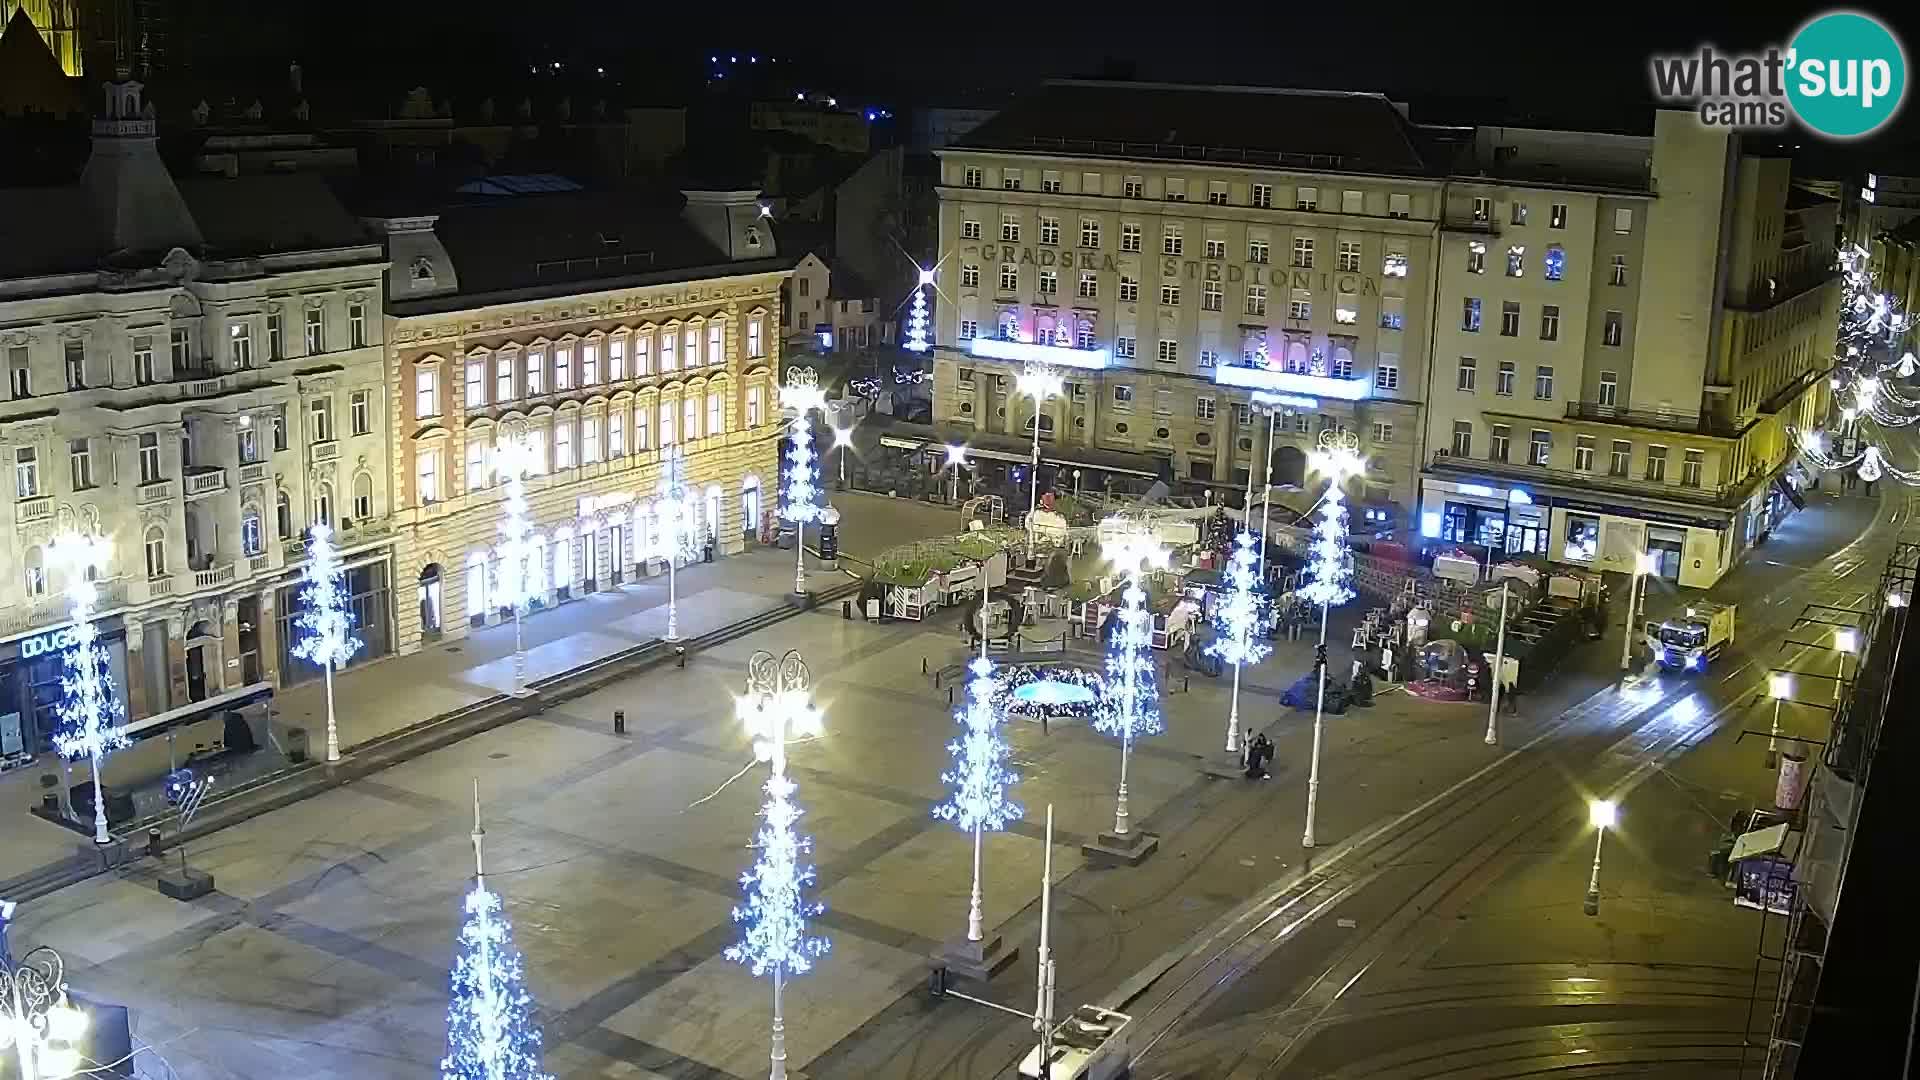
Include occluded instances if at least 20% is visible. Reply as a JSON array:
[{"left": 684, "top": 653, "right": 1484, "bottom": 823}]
[{"left": 933, "top": 83, "right": 1444, "bottom": 532}]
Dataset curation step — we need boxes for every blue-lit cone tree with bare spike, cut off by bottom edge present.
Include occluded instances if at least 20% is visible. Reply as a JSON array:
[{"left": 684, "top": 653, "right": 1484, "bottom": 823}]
[{"left": 440, "top": 780, "right": 553, "bottom": 1080}]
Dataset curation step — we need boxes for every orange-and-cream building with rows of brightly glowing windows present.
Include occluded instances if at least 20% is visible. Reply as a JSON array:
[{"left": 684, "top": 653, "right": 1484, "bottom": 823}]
[{"left": 378, "top": 184, "right": 793, "bottom": 651}]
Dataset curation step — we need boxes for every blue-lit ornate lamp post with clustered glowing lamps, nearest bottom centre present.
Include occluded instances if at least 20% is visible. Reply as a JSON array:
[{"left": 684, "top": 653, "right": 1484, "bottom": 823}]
[{"left": 726, "top": 650, "right": 829, "bottom": 1080}]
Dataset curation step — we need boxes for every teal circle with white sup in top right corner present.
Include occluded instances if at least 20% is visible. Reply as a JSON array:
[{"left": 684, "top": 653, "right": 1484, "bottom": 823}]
[{"left": 1786, "top": 12, "right": 1907, "bottom": 138}]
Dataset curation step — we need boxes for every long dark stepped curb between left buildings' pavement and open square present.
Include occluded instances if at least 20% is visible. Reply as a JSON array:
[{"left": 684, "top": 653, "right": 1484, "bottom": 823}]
[{"left": 0, "top": 580, "right": 860, "bottom": 901}]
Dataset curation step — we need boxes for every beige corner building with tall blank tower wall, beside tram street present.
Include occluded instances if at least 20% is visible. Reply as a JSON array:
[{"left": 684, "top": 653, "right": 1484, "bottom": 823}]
[{"left": 1421, "top": 110, "right": 1839, "bottom": 588}]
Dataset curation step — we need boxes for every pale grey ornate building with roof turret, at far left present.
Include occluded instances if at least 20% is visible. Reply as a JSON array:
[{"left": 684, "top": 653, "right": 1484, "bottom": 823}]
[{"left": 0, "top": 71, "right": 392, "bottom": 757}]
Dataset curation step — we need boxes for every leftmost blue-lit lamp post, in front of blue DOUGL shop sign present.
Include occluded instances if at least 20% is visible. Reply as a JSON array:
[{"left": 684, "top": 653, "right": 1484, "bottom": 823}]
[{"left": 48, "top": 530, "right": 129, "bottom": 844}]
